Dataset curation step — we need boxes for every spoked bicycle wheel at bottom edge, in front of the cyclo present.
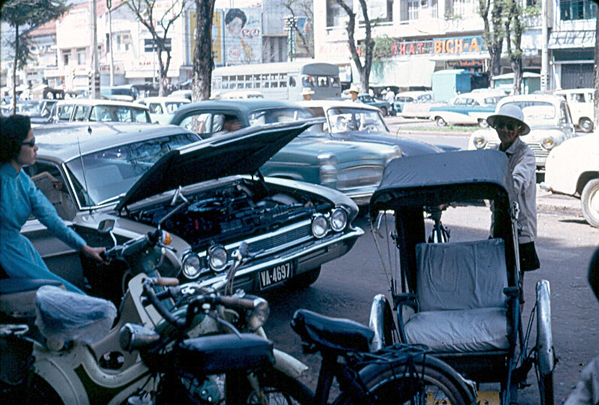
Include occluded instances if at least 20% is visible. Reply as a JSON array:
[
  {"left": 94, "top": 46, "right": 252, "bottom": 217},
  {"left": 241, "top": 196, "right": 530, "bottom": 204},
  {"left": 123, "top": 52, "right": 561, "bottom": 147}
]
[{"left": 334, "top": 355, "right": 475, "bottom": 405}]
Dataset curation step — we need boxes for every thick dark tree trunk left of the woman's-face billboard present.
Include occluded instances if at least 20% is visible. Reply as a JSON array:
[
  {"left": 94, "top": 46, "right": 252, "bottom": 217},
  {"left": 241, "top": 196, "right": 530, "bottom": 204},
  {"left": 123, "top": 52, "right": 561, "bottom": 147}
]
[{"left": 191, "top": 0, "right": 215, "bottom": 101}]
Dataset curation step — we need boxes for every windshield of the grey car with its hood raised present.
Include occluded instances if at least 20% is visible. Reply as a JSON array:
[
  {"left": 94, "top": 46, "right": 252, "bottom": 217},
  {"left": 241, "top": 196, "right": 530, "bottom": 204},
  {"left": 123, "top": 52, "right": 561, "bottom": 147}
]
[{"left": 66, "top": 134, "right": 198, "bottom": 207}]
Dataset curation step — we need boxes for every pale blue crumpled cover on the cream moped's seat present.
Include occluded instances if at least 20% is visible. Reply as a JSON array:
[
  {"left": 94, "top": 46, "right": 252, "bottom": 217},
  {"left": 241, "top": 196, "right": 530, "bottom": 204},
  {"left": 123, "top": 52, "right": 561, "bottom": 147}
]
[{"left": 35, "top": 286, "right": 117, "bottom": 344}]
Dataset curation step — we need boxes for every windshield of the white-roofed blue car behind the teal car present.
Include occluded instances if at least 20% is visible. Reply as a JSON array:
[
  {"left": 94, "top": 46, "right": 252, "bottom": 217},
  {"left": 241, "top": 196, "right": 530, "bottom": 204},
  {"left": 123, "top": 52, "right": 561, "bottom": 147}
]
[{"left": 327, "top": 108, "right": 388, "bottom": 133}]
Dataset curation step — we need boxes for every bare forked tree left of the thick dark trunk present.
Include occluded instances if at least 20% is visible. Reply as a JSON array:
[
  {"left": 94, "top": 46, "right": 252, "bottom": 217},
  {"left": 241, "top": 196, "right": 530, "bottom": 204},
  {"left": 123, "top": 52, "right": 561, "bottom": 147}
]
[{"left": 125, "top": 0, "right": 187, "bottom": 96}]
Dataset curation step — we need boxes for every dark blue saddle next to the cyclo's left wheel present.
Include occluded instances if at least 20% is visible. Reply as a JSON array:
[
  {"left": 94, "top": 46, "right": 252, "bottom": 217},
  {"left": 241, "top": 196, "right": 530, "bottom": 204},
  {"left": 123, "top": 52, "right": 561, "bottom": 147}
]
[{"left": 291, "top": 309, "right": 374, "bottom": 352}]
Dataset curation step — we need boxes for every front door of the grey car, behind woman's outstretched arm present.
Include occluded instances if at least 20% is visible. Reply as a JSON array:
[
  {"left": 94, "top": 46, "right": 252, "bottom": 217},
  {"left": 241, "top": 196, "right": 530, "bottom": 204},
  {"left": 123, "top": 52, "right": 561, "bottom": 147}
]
[{"left": 21, "top": 159, "right": 84, "bottom": 288}]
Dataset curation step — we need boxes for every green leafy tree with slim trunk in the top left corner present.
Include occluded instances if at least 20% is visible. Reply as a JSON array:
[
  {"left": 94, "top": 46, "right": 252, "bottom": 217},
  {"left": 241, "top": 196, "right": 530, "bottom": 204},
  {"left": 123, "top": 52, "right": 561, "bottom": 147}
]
[{"left": 1, "top": 0, "right": 69, "bottom": 114}]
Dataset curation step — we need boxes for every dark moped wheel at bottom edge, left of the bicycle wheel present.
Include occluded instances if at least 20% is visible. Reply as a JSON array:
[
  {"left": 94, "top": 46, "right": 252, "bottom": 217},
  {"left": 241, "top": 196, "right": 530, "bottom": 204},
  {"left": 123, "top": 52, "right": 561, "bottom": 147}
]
[{"left": 225, "top": 369, "right": 314, "bottom": 405}]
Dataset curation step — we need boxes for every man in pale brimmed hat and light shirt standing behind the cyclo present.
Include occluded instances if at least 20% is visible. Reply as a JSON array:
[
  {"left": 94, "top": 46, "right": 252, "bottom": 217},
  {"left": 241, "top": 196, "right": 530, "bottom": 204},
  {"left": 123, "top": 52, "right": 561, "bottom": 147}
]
[{"left": 487, "top": 104, "right": 541, "bottom": 272}]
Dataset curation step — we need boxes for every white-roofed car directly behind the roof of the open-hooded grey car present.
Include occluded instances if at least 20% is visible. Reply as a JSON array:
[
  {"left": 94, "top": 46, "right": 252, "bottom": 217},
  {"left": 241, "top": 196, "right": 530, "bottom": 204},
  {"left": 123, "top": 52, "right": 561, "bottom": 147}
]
[{"left": 53, "top": 98, "right": 152, "bottom": 123}]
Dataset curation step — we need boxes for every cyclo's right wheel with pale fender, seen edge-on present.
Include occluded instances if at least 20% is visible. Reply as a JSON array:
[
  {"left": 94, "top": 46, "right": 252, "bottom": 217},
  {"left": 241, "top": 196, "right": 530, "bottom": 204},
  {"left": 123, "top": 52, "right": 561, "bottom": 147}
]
[{"left": 535, "top": 280, "right": 555, "bottom": 405}]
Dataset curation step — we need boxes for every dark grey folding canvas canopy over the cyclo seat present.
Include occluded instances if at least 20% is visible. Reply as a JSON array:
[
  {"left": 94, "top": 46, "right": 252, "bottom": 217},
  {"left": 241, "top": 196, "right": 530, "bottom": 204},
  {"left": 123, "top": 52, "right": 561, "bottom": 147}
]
[{"left": 370, "top": 150, "right": 518, "bottom": 290}]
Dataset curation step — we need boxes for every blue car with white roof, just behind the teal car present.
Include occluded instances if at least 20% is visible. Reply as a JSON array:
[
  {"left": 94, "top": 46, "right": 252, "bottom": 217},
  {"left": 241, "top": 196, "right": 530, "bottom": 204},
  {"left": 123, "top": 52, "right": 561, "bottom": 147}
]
[{"left": 298, "top": 100, "right": 443, "bottom": 156}]
